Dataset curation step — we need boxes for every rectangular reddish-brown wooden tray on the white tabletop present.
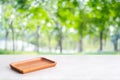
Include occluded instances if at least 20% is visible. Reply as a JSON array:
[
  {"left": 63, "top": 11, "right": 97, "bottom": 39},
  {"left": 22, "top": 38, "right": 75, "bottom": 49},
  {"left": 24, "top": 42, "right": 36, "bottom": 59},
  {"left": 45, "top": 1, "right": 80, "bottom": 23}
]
[{"left": 10, "top": 57, "right": 56, "bottom": 74}]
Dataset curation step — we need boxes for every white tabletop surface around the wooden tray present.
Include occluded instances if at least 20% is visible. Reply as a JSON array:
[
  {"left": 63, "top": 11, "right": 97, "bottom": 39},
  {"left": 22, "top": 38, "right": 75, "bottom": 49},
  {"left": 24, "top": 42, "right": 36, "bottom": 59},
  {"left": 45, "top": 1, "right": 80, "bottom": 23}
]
[{"left": 0, "top": 55, "right": 120, "bottom": 80}]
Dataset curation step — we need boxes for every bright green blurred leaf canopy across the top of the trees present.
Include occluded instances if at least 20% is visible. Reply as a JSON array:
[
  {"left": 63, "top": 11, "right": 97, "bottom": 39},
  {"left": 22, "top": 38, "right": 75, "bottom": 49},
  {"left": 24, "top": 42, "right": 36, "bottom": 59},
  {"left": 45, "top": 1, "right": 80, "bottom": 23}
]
[{"left": 0, "top": 0, "right": 120, "bottom": 53}]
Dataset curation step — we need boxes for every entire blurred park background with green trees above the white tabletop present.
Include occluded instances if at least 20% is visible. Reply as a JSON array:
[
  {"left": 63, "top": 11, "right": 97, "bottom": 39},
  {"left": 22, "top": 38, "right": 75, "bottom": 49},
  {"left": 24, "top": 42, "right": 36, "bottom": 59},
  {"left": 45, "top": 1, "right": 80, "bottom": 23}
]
[{"left": 0, "top": 0, "right": 120, "bottom": 54}]
